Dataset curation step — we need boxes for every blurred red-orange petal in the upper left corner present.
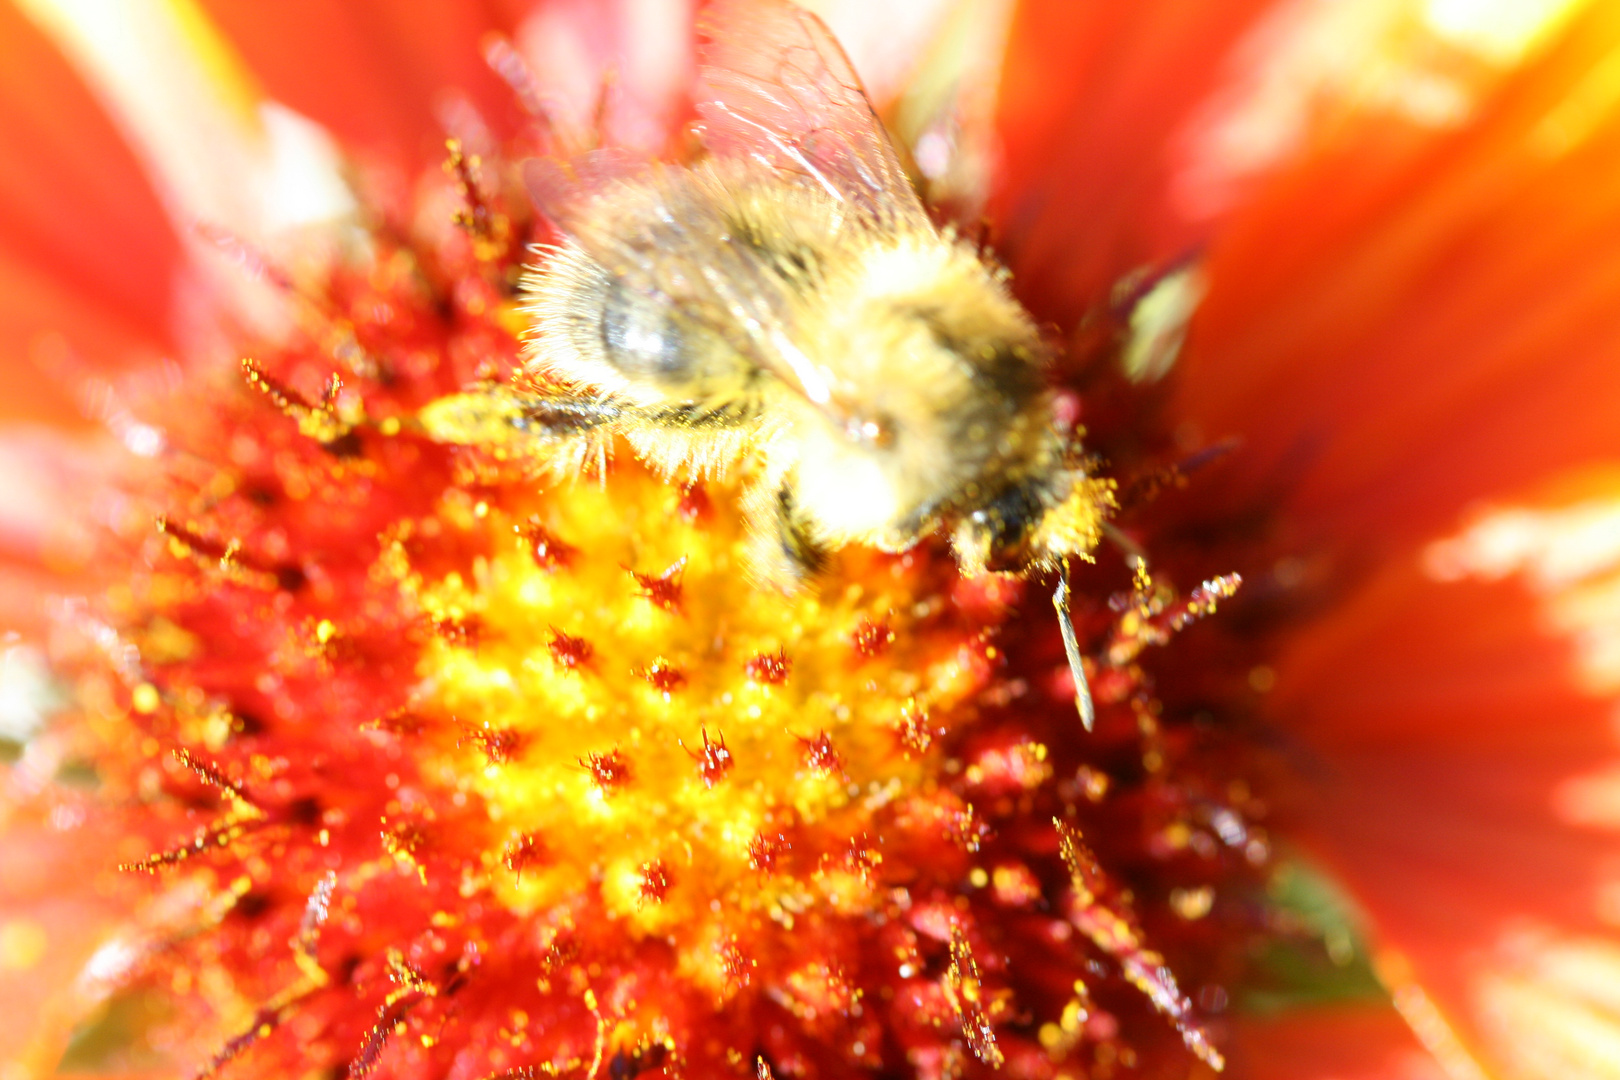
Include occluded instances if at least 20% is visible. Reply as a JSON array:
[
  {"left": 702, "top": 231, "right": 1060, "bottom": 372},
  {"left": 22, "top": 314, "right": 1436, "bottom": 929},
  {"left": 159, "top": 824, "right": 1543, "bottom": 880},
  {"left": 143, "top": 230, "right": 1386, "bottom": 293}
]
[{"left": 0, "top": 5, "right": 180, "bottom": 424}]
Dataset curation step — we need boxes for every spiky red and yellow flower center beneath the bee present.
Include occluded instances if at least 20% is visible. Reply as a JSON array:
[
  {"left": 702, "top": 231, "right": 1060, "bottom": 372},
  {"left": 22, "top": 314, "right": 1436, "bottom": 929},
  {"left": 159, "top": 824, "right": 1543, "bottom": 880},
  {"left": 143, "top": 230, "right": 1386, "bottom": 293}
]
[{"left": 28, "top": 128, "right": 1289, "bottom": 1080}]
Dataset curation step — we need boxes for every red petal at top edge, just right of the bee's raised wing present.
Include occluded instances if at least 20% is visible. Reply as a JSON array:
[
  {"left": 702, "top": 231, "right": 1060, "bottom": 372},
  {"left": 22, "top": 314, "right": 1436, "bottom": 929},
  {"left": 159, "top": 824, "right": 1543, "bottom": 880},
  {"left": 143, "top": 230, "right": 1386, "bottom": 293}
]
[{"left": 993, "top": 0, "right": 1270, "bottom": 324}]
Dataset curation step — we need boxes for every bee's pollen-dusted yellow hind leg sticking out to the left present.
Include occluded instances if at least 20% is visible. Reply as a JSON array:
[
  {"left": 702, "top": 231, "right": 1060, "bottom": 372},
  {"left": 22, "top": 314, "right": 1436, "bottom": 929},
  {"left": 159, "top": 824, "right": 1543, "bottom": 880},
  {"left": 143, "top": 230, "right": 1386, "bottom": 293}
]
[{"left": 416, "top": 387, "right": 624, "bottom": 447}]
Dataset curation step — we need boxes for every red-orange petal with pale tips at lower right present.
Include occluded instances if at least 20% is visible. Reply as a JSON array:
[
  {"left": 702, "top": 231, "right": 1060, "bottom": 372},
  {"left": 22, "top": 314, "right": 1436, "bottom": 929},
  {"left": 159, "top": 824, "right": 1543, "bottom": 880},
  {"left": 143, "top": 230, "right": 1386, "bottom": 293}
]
[{"left": 1267, "top": 485, "right": 1620, "bottom": 1078}]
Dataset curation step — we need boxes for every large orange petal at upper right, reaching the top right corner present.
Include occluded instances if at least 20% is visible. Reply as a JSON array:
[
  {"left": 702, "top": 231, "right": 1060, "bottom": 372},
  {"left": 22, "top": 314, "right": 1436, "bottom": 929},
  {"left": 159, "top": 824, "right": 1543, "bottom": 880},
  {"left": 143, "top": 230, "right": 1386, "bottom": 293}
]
[{"left": 1176, "top": 3, "right": 1620, "bottom": 546}]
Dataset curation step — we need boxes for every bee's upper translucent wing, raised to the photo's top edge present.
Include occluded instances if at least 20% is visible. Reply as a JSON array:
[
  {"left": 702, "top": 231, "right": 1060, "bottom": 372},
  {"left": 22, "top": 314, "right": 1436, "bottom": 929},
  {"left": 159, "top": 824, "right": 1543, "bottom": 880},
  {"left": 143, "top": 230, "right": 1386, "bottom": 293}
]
[{"left": 698, "top": 0, "right": 927, "bottom": 223}]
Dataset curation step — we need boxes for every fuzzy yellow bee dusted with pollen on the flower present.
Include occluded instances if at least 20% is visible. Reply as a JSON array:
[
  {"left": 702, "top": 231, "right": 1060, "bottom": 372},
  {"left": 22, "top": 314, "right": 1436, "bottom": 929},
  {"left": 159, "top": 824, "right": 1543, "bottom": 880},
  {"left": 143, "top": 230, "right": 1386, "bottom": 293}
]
[{"left": 421, "top": 0, "right": 1106, "bottom": 727}]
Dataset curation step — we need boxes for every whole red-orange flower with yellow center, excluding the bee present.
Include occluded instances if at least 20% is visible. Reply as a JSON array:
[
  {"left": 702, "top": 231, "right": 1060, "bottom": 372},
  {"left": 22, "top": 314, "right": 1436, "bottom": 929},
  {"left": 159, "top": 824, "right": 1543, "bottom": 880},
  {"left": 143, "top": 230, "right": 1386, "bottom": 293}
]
[{"left": 0, "top": 0, "right": 1620, "bottom": 1077}]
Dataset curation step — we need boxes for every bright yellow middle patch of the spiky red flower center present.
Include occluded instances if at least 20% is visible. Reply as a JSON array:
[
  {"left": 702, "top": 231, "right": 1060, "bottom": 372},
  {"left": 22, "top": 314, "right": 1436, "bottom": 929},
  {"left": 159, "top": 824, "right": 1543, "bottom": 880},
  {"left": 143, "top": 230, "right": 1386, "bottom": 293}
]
[{"left": 398, "top": 455, "right": 996, "bottom": 993}]
